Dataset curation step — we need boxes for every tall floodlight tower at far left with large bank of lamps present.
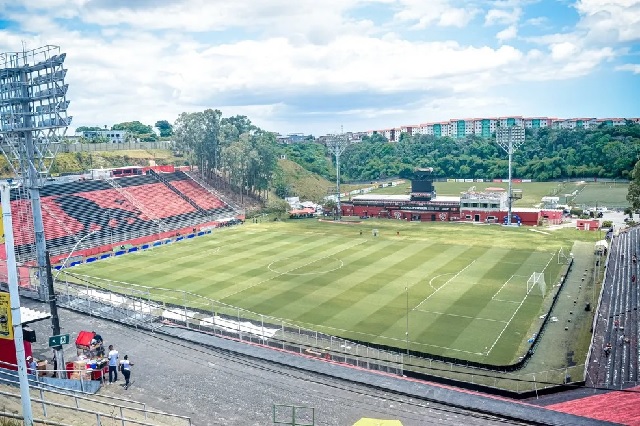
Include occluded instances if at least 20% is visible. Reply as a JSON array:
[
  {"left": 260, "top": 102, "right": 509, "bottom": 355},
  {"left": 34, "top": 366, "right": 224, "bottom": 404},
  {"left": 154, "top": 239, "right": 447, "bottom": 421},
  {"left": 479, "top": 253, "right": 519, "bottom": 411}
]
[{"left": 0, "top": 45, "right": 72, "bottom": 301}]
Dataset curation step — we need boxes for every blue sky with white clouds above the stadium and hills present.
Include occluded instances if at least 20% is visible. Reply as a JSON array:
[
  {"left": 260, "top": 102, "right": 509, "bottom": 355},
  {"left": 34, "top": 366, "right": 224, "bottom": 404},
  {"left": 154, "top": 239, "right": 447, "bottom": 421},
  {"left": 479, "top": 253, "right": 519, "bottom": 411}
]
[{"left": 0, "top": 0, "right": 640, "bottom": 136}]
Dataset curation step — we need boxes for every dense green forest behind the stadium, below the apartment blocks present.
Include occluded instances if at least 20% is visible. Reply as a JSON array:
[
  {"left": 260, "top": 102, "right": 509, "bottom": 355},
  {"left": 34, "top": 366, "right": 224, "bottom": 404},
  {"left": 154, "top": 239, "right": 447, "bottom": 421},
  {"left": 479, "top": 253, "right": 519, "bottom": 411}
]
[{"left": 281, "top": 124, "right": 640, "bottom": 181}]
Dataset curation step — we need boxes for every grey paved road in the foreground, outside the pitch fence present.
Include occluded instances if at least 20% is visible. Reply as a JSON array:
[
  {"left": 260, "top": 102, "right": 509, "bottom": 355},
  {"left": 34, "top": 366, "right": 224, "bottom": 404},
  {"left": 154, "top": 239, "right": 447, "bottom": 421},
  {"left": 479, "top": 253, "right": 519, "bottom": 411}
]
[{"left": 23, "top": 299, "right": 528, "bottom": 426}]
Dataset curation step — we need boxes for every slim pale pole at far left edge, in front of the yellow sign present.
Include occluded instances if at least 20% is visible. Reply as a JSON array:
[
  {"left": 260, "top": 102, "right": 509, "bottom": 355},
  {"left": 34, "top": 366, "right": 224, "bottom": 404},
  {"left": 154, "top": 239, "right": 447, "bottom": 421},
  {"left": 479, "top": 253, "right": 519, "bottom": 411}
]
[{"left": 0, "top": 183, "right": 33, "bottom": 426}]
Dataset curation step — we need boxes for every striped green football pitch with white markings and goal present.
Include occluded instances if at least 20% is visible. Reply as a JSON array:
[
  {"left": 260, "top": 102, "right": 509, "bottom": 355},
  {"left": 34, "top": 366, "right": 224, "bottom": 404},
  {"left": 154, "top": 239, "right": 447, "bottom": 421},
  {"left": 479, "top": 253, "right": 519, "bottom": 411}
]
[{"left": 70, "top": 220, "right": 595, "bottom": 364}]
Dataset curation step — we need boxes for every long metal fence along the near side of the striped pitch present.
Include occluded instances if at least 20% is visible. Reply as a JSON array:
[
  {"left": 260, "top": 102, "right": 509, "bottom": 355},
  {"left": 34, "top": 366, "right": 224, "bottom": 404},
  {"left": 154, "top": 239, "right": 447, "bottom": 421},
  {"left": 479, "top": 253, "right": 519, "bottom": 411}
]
[{"left": 51, "top": 270, "right": 585, "bottom": 393}]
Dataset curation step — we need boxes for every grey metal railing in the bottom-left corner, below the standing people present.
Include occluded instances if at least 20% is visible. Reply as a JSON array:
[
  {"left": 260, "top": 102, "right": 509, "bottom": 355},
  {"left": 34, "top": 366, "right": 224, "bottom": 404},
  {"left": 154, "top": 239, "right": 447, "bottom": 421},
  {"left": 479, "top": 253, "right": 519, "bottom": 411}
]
[{"left": 0, "top": 362, "right": 191, "bottom": 425}]
